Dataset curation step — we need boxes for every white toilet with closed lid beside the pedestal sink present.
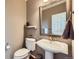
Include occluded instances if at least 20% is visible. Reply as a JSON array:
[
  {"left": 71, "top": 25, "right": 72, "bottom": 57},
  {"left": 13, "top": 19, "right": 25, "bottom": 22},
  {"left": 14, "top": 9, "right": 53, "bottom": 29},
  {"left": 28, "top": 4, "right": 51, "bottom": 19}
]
[{"left": 14, "top": 38, "right": 36, "bottom": 59}]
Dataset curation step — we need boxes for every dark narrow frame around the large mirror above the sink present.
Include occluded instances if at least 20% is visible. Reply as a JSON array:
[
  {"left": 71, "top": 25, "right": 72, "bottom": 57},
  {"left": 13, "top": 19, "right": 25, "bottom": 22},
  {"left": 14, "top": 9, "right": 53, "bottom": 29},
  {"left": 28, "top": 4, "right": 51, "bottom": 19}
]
[{"left": 39, "top": 2, "right": 67, "bottom": 37}]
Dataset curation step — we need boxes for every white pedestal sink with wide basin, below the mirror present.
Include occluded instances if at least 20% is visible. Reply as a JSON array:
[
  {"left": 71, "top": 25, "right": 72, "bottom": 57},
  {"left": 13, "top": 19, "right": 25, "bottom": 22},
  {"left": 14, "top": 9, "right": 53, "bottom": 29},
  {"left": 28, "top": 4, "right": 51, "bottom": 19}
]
[{"left": 37, "top": 39, "right": 68, "bottom": 59}]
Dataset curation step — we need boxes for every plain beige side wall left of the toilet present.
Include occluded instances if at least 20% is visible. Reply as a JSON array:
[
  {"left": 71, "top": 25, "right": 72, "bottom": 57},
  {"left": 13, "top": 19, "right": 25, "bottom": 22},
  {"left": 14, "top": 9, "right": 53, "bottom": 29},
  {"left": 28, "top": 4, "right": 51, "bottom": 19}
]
[{"left": 5, "top": 0, "right": 26, "bottom": 59}]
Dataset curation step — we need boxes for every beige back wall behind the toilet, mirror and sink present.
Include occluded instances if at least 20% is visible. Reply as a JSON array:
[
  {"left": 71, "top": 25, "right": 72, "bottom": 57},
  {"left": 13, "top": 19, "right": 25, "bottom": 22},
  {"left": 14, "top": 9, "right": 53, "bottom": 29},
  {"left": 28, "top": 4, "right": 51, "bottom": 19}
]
[{"left": 27, "top": 0, "right": 72, "bottom": 59}]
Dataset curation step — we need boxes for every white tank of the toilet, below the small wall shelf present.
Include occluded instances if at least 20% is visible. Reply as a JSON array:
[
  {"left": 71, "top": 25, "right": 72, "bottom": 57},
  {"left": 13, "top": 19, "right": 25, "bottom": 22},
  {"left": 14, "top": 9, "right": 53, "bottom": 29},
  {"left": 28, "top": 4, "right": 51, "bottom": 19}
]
[{"left": 25, "top": 38, "right": 36, "bottom": 51}]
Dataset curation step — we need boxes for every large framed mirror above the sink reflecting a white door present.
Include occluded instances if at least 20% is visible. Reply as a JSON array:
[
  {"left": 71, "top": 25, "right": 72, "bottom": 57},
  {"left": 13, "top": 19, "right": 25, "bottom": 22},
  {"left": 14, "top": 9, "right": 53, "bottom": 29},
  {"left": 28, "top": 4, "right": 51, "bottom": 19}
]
[{"left": 39, "top": 0, "right": 66, "bottom": 36}]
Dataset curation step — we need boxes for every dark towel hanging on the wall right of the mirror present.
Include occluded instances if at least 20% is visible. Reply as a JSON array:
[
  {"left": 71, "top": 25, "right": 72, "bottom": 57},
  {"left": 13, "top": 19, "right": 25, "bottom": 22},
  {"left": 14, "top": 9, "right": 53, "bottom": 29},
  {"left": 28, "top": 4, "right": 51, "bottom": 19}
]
[{"left": 62, "top": 20, "right": 74, "bottom": 40}]
